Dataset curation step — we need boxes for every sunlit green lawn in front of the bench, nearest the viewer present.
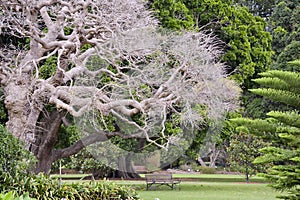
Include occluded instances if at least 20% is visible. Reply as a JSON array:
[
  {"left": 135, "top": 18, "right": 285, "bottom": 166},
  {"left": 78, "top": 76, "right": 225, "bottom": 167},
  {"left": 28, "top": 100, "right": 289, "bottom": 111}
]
[{"left": 139, "top": 182, "right": 279, "bottom": 200}]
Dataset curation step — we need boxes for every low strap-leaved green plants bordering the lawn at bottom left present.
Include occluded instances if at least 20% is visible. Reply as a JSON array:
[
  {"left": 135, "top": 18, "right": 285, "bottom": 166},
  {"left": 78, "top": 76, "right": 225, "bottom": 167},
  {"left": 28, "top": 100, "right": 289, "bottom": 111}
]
[{"left": 0, "top": 174, "right": 140, "bottom": 200}]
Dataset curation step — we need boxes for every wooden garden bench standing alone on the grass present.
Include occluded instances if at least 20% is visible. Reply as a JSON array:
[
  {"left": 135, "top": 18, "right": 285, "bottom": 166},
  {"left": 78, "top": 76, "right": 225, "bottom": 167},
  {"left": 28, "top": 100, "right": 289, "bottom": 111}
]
[{"left": 145, "top": 174, "right": 181, "bottom": 190}]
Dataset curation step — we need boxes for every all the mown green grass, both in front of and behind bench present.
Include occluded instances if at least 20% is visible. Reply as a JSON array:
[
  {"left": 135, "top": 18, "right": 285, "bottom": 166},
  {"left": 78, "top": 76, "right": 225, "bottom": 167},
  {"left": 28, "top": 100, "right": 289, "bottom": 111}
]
[{"left": 55, "top": 174, "right": 280, "bottom": 200}]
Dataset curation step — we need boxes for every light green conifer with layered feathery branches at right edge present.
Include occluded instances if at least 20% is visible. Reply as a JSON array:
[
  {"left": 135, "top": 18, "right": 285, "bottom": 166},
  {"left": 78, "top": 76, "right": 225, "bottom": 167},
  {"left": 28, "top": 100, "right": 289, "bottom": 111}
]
[{"left": 234, "top": 62, "right": 300, "bottom": 200}]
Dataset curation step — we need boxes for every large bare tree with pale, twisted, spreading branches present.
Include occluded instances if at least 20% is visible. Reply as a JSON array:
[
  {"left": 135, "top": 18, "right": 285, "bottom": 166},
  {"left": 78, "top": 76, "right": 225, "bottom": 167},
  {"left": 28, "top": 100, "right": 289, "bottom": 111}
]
[{"left": 0, "top": 0, "right": 238, "bottom": 172}]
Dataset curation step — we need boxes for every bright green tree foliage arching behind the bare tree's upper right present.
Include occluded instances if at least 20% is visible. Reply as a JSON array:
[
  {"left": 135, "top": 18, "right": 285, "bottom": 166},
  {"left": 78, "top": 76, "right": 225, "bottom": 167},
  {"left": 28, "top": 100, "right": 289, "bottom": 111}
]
[{"left": 152, "top": 0, "right": 272, "bottom": 87}]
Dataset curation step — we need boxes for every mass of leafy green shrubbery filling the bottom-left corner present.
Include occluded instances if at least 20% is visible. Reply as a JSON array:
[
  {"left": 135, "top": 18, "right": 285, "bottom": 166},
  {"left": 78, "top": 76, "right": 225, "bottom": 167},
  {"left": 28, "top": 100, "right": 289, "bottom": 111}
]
[{"left": 0, "top": 125, "right": 139, "bottom": 200}]
